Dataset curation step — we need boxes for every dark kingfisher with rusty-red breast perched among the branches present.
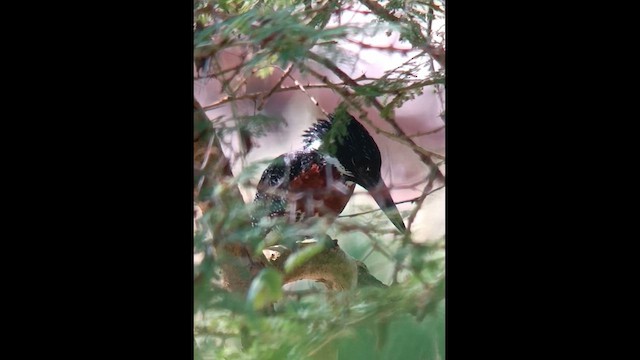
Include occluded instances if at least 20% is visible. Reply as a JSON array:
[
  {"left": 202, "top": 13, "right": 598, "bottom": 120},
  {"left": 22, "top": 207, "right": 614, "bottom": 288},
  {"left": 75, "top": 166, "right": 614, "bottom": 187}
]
[{"left": 254, "top": 112, "right": 406, "bottom": 233}]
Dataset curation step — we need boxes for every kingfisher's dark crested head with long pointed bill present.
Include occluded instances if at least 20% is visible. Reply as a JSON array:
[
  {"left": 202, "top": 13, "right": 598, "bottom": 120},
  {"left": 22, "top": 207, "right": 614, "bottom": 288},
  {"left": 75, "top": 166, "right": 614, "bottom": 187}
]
[{"left": 304, "top": 113, "right": 406, "bottom": 233}]
